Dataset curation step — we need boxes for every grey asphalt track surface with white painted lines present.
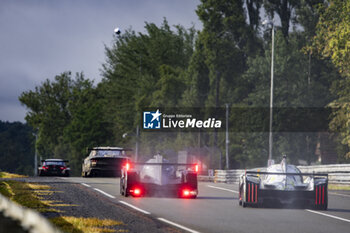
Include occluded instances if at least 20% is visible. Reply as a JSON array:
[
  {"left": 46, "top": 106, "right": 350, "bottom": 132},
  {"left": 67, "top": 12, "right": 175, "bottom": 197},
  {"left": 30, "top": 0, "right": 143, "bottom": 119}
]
[{"left": 62, "top": 177, "right": 350, "bottom": 232}]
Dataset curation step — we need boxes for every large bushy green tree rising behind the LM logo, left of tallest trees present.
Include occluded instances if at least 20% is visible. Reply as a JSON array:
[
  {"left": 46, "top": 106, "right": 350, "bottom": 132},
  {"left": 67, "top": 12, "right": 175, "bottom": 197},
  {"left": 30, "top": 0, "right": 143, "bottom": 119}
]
[{"left": 99, "top": 20, "right": 196, "bottom": 155}]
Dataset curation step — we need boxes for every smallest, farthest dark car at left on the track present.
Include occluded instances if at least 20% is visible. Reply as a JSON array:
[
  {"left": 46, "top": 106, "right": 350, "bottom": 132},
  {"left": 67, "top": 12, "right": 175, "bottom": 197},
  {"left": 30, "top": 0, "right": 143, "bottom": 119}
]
[{"left": 38, "top": 159, "right": 70, "bottom": 176}]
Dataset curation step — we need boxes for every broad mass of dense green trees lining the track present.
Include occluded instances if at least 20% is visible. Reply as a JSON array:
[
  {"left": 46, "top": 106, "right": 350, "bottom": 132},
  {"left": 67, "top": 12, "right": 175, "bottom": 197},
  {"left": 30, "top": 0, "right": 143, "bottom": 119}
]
[{"left": 20, "top": 0, "right": 350, "bottom": 174}]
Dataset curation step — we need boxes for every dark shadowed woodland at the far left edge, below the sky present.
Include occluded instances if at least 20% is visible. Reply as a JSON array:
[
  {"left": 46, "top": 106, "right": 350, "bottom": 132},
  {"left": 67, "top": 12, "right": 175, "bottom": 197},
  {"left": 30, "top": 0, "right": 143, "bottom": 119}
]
[{"left": 0, "top": 121, "right": 35, "bottom": 175}]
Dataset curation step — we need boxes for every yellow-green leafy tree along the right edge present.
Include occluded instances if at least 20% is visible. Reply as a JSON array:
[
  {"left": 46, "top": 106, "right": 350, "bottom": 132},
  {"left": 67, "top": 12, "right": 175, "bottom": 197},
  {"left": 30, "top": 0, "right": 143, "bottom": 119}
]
[{"left": 313, "top": 0, "right": 350, "bottom": 158}]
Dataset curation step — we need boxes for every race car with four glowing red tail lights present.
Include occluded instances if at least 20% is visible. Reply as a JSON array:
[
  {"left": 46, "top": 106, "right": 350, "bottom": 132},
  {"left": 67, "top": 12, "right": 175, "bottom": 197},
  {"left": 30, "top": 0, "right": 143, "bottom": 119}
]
[{"left": 120, "top": 155, "right": 198, "bottom": 198}]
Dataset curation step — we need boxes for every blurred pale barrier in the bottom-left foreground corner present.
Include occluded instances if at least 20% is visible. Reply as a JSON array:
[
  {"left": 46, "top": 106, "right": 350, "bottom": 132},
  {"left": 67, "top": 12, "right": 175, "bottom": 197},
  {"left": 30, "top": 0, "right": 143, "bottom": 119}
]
[{"left": 0, "top": 194, "right": 61, "bottom": 233}]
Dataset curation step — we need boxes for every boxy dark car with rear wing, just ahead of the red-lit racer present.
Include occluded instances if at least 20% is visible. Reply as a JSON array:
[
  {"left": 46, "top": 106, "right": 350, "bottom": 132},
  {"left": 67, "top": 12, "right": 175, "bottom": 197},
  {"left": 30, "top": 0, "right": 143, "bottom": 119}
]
[{"left": 82, "top": 147, "right": 130, "bottom": 177}]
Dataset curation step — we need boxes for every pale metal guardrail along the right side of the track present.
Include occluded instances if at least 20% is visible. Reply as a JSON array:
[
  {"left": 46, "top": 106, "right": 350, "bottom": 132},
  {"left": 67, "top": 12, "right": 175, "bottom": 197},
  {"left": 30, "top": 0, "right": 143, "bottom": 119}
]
[{"left": 213, "top": 164, "right": 350, "bottom": 185}]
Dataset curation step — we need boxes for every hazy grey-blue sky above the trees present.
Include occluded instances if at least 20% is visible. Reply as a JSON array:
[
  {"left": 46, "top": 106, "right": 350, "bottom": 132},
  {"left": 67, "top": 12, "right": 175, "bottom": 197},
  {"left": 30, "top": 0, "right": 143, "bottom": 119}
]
[{"left": 0, "top": 0, "right": 202, "bottom": 122}]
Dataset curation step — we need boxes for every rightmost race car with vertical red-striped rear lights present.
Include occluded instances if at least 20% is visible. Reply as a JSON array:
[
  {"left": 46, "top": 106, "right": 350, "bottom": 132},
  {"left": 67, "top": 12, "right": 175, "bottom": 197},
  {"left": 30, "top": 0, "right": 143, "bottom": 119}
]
[{"left": 239, "top": 158, "right": 328, "bottom": 210}]
